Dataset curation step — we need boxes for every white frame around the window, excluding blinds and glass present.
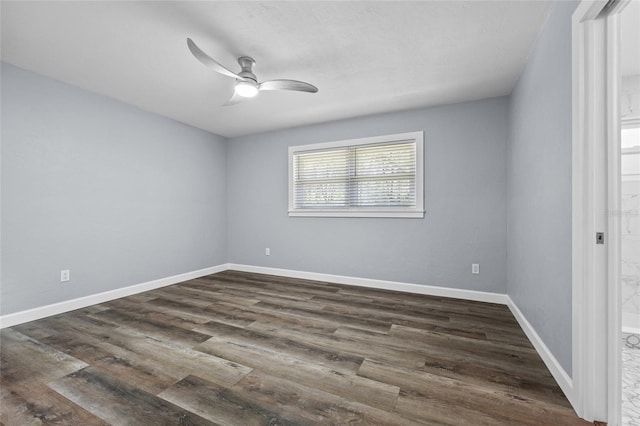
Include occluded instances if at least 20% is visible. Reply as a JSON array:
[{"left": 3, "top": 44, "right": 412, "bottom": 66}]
[{"left": 288, "top": 131, "right": 425, "bottom": 218}]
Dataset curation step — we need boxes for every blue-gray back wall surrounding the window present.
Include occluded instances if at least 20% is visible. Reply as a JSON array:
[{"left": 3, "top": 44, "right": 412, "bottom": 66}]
[{"left": 227, "top": 98, "right": 507, "bottom": 293}]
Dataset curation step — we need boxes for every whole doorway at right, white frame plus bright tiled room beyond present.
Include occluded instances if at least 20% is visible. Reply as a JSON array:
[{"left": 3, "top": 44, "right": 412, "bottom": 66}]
[{"left": 572, "top": 0, "right": 640, "bottom": 426}]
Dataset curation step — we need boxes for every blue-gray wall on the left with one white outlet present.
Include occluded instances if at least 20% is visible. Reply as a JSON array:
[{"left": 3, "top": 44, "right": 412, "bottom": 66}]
[{"left": 0, "top": 64, "right": 227, "bottom": 315}]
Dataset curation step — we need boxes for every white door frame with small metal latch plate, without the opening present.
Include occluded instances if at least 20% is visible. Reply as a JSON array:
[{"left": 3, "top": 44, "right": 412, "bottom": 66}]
[{"left": 569, "top": 0, "right": 630, "bottom": 426}]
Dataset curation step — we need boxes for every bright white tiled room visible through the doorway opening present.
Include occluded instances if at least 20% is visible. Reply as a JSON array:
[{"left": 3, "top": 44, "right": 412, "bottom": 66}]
[{"left": 619, "top": 1, "right": 640, "bottom": 426}]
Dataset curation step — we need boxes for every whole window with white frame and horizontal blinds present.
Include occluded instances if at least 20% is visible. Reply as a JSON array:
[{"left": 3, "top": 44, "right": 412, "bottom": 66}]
[{"left": 289, "top": 132, "right": 424, "bottom": 218}]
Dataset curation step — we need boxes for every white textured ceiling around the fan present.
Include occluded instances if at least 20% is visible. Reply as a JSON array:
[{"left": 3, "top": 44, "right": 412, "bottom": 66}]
[{"left": 0, "top": 1, "right": 551, "bottom": 137}]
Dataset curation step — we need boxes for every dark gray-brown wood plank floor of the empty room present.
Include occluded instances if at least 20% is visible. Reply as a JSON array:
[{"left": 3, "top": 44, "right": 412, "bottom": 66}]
[{"left": 0, "top": 271, "right": 587, "bottom": 426}]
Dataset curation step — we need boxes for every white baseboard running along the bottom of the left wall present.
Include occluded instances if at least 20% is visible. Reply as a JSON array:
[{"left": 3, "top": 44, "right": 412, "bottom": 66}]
[{"left": 0, "top": 264, "right": 228, "bottom": 329}]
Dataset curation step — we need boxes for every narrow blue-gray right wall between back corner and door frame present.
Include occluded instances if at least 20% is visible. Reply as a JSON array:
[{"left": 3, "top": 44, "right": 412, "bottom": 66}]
[{"left": 507, "top": 2, "right": 577, "bottom": 374}]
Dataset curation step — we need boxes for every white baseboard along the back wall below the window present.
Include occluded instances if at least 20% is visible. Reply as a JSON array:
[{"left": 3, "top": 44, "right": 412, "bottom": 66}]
[{"left": 227, "top": 263, "right": 508, "bottom": 305}]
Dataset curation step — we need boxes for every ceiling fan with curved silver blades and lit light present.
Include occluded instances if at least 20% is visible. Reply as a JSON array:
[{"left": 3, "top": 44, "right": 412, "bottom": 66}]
[{"left": 187, "top": 38, "right": 318, "bottom": 105}]
